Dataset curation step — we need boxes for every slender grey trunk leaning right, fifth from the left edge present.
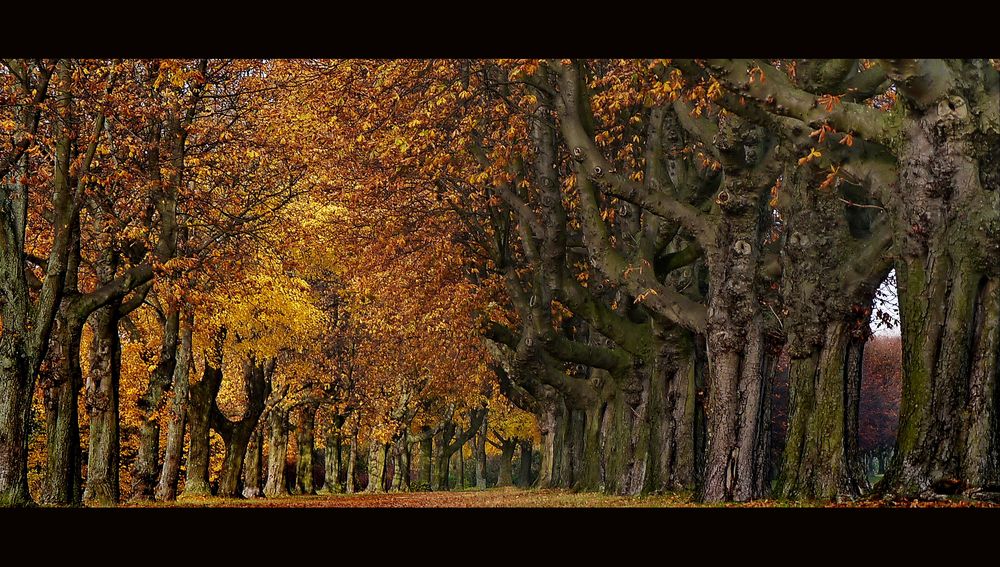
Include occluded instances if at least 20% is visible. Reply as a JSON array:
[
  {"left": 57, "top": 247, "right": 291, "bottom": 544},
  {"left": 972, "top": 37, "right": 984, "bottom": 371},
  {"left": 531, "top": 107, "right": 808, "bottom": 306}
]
[{"left": 155, "top": 315, "right": 194, "bottom": 501}]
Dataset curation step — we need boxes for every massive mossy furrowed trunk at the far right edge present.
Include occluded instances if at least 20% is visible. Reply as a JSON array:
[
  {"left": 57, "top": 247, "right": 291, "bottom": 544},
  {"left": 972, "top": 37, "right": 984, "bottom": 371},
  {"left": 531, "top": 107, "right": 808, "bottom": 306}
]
[{"left": 880, "top": 70, "right": 1000, "bottom": 497}]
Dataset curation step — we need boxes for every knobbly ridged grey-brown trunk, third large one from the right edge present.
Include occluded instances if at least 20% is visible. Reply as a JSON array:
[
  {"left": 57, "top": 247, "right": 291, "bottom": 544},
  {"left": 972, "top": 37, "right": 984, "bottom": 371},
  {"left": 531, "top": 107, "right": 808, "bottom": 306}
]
[{"left": 700, "top": 150, "right": 777, "bottom": 502}]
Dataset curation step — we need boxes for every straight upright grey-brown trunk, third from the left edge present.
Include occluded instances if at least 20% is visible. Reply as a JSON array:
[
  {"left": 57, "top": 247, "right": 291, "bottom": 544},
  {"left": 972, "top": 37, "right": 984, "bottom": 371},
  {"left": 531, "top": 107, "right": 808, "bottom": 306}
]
[{"left": 84, "top": 305, "right": 121, "bottom": 506}]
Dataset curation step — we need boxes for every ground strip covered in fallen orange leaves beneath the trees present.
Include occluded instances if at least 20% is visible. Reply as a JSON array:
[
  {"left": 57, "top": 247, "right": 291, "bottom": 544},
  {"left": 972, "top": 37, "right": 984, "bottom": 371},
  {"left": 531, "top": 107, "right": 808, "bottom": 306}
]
[{"left": 126, "top": 488, "right": 1000, "bottom": 508}]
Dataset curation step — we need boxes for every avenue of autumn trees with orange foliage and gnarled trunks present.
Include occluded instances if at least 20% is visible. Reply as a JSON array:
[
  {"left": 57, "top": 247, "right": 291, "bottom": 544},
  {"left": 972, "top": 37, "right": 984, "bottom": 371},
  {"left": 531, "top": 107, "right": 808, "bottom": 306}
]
[{"left": 0, "top": 59, "right": 1000, "bottom": 506}]
